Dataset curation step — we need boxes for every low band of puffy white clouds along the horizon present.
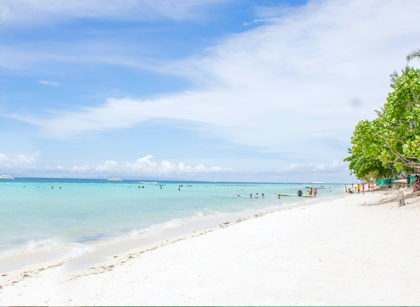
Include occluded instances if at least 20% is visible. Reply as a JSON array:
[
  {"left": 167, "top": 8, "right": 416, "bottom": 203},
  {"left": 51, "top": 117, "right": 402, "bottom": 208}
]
[{"left": 0, "top": 153, "right": 351, "bottom": 182}]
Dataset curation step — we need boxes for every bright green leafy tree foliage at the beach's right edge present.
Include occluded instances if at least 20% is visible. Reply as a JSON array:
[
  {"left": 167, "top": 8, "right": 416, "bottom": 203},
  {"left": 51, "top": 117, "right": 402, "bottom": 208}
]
[{"left": 344, "top": 53, "right": 420, "bottom": 178}]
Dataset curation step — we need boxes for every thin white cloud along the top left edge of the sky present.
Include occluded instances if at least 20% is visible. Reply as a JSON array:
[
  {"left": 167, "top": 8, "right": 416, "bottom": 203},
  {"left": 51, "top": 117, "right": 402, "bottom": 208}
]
[{"left": 0, "top": 0, "right": 233, "bottom": 25}]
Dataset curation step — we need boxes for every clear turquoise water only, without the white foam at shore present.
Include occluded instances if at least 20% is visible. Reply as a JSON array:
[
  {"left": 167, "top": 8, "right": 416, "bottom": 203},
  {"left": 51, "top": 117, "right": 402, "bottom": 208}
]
[{"left": 0, "top": 179, "right": 343, "bottom": 252}]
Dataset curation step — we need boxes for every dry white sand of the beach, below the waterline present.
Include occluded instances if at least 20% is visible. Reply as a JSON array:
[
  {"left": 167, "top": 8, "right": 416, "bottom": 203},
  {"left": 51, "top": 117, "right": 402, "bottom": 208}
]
[{"left": 0, "top": 192, "right": 420, "bottom": 305}]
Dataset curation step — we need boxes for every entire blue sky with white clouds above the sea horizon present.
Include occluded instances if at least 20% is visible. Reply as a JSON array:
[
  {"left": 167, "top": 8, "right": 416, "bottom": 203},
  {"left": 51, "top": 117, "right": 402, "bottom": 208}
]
[{"left": 0, "top": 0, "right": 420, "bottom": 182}]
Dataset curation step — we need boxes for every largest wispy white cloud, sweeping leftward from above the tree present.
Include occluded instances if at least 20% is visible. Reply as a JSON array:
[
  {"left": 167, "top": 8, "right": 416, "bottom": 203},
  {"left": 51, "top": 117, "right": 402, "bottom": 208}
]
[{"left": 9, "top": 0, "right": 420, "bottom": 162}]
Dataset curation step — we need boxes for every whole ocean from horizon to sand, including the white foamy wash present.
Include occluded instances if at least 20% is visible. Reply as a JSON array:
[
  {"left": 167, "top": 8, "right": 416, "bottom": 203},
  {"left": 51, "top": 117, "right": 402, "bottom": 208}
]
[{"left": 0, "top": 178, "right": 344, "bottom": 270}]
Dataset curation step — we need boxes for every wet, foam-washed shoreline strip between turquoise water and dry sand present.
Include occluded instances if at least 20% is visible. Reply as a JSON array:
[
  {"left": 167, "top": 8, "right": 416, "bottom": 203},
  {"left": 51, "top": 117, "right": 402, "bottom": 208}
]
[{"left": 0, "top": 194, "right": 345, "bottom": 276}]
